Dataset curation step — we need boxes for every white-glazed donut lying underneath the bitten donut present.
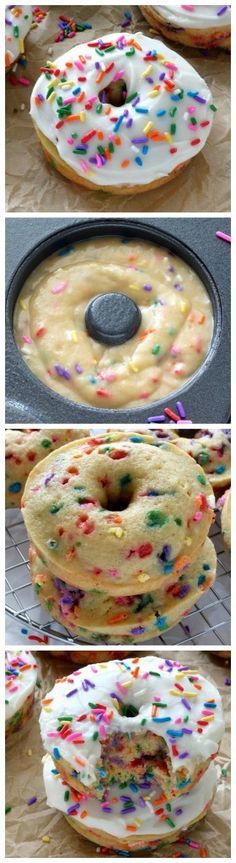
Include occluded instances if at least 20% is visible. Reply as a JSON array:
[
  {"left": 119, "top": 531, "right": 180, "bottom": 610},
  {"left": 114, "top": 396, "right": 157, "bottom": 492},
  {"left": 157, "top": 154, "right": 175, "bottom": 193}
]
[{"left": 43, "top": 755, "right": 217, "bottom": 852}]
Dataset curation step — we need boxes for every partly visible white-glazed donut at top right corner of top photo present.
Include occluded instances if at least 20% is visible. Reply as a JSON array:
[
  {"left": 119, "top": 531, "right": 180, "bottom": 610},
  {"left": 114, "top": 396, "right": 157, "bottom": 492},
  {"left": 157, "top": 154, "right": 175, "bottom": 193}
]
[{"left": 140, "top": 3, "right": 231, "bottom": 50}]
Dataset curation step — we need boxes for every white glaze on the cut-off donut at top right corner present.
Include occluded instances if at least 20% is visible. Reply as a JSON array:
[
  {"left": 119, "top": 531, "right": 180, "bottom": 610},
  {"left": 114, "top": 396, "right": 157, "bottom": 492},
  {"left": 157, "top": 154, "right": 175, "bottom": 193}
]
[{"left": 153, "top": 3, "right": 231, "bottom": 30}]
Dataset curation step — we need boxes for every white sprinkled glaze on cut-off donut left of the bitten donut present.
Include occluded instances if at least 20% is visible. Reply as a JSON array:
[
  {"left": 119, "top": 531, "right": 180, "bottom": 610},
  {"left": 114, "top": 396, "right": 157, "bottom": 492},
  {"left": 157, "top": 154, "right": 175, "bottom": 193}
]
[{"left": 5, "top": 650, "right": 38, "bottom": 721}]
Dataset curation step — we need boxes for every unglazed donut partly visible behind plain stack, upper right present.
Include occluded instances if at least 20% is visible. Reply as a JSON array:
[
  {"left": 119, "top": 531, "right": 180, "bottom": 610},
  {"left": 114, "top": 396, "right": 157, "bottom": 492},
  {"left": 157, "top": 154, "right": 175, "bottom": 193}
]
[{"left": 175, "top": 428, "right": 231, "bottom": 489}]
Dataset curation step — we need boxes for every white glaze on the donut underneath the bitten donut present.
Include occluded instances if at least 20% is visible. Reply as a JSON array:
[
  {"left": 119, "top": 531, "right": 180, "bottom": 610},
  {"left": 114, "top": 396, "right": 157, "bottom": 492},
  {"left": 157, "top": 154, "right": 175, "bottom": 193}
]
[{"left": 43, "top": 756, "right": 217, "bottom": 840}]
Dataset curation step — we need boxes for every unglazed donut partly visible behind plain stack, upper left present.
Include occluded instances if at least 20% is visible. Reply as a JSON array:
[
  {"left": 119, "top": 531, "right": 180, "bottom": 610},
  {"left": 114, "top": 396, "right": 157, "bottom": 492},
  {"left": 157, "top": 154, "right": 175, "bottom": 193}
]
[{"left": 5, "top": 426, "right": 86, "bottom": 509}]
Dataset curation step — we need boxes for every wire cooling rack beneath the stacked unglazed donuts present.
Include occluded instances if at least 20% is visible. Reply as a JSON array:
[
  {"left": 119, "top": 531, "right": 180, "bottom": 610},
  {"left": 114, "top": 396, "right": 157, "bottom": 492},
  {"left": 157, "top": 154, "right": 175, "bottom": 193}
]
[{"left": 6, "top": 509, "right": 230, "bottom": 646}]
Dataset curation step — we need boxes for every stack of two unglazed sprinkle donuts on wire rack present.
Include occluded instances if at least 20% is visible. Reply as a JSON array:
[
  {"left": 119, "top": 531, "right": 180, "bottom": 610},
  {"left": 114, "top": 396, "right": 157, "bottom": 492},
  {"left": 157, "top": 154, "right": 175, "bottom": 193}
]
[{"left": 22, "top": 431, "right": 216, "bottom": 644}]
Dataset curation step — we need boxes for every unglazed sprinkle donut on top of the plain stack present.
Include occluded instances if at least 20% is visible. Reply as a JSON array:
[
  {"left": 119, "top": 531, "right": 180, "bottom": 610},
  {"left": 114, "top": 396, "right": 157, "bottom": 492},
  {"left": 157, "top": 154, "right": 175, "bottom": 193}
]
[{"left": 22, "top": 431, "right": 214, "bottom": 596}]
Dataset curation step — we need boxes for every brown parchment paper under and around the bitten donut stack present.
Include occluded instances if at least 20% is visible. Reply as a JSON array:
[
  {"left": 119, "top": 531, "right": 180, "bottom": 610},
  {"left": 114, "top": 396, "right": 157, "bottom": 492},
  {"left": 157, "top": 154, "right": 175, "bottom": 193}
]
[{"left": 6, "top": 650, "right": 230, "bottom": 860}]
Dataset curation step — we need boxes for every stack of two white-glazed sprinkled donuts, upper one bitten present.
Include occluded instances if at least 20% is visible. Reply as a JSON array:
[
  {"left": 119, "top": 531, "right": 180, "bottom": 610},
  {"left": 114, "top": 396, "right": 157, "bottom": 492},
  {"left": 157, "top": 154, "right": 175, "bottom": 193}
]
[{"left": 40, "top": 656, "right": 224, "bottom": 851}]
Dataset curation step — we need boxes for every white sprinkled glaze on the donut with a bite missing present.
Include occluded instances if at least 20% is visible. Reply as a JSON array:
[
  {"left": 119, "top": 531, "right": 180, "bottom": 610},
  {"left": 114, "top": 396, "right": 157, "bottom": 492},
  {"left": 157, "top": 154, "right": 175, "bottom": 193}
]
[{"left": 40, "top": 656, "right": 224, "bottom": 787}]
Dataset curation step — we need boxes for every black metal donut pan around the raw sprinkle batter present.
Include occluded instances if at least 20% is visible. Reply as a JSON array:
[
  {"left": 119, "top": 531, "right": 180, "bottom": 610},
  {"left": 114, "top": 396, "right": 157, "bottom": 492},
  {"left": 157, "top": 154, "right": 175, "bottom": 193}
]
[{"left": 6, "top": 216, "right": 230, "bottom": 425}]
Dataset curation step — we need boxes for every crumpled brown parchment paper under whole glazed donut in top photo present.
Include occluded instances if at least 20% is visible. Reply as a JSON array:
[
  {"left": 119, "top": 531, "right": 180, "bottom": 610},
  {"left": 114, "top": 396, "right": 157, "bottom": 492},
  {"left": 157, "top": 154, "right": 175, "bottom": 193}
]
[{"left": 6, "top": 4, "right": 230, "bottom": 213}]
